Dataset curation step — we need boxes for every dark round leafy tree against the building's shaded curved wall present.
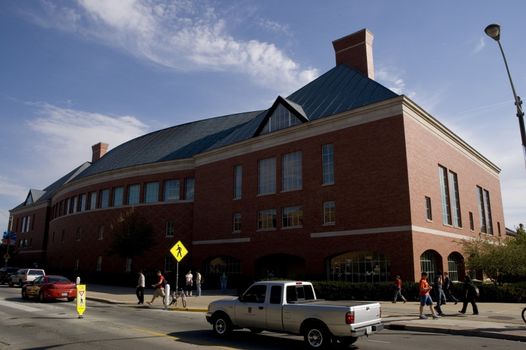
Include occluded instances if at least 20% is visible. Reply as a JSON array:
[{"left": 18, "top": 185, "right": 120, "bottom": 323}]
[{"left": 109, "top": 209, "right": 154, "bottom": 258}]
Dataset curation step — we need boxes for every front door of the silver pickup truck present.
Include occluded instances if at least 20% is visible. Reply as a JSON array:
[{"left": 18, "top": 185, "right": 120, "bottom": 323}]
[{"left": 235, "top": 284, "right": 267, "bottom": 329}]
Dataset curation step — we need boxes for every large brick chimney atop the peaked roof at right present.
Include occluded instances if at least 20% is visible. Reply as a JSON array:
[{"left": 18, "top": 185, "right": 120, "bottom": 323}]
[{"left": 332, "top": 28, "right": 374, "bottom": 79}]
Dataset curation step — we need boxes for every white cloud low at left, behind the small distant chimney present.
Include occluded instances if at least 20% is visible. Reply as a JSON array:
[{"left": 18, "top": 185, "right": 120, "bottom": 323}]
[{"left": 28, "top": 104, "right": 148, "bottom": 175}]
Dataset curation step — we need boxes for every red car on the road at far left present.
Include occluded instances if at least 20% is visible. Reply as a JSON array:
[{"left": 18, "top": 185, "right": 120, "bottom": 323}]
[{"left": 22, "top": 275, "right": 77, "bottom": 302}]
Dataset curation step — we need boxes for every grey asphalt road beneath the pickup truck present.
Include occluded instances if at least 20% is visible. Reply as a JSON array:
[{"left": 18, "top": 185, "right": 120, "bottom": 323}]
[{"left": 0, "top": 286, "right": 526, "bottom": 350}]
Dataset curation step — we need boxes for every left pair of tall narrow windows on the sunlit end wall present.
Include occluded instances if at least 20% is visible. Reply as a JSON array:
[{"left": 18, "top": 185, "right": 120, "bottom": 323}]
[{"left": 438, "top": 166, "right": 462, "bottom": 227}]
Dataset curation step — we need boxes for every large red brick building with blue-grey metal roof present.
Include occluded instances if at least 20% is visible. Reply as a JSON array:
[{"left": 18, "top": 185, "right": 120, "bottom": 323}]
[{"left": 11, "top": 30, "right": 505, "bottom": 285}]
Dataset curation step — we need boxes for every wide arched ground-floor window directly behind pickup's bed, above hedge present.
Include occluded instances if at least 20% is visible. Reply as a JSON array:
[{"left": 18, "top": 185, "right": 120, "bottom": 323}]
[{"left": 328, "top": 251, "right": 391, "bottom": 282}]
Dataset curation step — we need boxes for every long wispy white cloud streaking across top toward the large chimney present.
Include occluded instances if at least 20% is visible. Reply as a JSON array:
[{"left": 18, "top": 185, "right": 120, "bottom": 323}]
[{"left": 37, "top": 0, "right": 319, "bottom": 92}]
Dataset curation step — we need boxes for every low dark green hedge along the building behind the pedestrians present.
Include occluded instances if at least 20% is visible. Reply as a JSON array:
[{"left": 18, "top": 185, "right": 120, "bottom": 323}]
[{"left": 312, "top": 281, "right": 526, "bottom": 303}]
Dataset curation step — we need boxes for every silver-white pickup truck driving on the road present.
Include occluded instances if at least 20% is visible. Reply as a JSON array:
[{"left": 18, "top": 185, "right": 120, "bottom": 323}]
[{"left": 206, "top": 281, "right": 383, "bottom": 349}]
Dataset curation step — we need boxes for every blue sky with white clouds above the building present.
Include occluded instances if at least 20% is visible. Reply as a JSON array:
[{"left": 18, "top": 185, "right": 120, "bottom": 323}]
[{"left": 0, "top": 0, "right": 526, "bottom": 230}]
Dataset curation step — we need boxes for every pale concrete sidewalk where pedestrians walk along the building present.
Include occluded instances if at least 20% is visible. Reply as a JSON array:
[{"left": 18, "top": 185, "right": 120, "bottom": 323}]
[{"left": 86, "top": 284, "right": 526, "bottom": 342}]
